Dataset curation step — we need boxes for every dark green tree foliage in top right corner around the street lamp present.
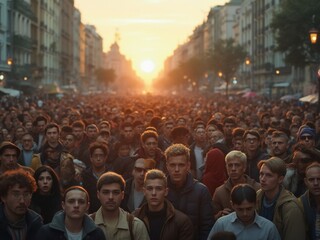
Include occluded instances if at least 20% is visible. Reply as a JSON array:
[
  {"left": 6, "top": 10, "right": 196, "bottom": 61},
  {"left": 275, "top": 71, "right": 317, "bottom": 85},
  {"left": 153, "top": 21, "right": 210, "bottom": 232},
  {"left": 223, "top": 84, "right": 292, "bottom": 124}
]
[{"left": 271, "top": 0, "right": 320, "bottom": 67}]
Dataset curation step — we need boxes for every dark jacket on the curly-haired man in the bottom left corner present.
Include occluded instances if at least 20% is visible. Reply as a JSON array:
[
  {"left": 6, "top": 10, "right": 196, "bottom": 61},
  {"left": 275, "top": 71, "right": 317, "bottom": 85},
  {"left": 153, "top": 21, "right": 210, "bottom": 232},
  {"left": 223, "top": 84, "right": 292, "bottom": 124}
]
[{"left": 0, "top": 204, "right": 43, "bottom": 240}]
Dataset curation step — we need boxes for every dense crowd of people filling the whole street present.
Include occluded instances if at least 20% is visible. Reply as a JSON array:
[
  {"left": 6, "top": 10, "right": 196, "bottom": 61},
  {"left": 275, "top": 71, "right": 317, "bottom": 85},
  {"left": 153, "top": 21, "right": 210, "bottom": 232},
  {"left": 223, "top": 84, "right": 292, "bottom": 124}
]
[{"left": 0, "top": 94, "right": 320, "bottom": 240}]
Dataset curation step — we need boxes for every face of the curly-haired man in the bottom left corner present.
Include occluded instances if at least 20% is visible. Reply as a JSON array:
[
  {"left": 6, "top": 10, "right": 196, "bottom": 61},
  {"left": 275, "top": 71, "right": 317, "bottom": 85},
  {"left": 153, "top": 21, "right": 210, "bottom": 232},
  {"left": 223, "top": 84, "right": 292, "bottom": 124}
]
[{"left": 1, "top": 184, "right": 32, "bottom": 220}]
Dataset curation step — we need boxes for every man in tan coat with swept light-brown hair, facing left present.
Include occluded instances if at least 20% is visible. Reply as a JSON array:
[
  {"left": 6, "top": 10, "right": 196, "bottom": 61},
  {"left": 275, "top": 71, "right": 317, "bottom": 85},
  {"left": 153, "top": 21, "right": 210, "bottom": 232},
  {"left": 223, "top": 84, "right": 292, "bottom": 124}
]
[{"left": 257, "top": 157, "right": 307, "bottom": 240}]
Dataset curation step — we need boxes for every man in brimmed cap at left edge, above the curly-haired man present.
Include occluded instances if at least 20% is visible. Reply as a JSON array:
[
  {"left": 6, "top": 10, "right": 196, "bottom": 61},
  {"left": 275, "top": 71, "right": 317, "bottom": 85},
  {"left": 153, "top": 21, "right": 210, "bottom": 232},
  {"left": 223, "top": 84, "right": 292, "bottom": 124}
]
[{"left": 0, "top": 141, "right": 34, "bottom": 175}]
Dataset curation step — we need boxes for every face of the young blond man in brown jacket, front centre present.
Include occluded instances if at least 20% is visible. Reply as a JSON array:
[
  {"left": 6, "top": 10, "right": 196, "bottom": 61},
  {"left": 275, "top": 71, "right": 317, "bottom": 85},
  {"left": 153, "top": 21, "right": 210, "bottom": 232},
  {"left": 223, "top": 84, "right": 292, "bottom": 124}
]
[{"left": 143, "top": 179, "right": 168, "bottom": 211}]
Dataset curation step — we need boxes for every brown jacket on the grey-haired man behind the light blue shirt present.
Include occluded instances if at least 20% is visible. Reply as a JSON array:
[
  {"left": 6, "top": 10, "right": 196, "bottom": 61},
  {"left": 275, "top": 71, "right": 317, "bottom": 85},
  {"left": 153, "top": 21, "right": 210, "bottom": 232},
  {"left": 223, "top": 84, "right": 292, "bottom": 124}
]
[{"left": 212, "top": 175, "right": 260, "bottom": 219}]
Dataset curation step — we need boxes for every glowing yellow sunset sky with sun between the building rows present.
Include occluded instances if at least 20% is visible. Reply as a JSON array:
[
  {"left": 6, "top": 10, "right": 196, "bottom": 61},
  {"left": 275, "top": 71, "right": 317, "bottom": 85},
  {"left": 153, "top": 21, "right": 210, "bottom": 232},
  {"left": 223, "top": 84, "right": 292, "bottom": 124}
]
[{"left": 75, "top": 0, "right": 228, "bottom": 80}]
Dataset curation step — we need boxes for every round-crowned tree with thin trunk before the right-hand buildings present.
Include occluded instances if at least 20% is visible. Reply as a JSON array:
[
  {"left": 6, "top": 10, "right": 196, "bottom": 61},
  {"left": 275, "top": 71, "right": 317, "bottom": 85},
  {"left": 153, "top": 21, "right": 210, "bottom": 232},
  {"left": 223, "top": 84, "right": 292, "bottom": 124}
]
[{"left": 208, "top": 39, "right": 247, "bottom": 97}]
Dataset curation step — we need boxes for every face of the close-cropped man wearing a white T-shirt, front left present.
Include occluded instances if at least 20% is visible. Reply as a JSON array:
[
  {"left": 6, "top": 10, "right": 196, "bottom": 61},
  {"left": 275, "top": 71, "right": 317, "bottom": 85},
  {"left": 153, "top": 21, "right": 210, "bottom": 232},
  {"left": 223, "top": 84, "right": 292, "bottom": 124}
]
[{"left": 62, "top": 189, "right": 89, "bottom": 219}]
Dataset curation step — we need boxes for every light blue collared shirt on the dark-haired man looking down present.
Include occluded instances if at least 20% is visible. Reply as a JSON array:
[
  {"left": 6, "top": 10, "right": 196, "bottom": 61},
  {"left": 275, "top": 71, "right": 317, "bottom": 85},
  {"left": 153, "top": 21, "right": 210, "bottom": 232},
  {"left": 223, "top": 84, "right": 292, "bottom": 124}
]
[{"left": 208, "top": 212, "right": 281, "bottom": 240}]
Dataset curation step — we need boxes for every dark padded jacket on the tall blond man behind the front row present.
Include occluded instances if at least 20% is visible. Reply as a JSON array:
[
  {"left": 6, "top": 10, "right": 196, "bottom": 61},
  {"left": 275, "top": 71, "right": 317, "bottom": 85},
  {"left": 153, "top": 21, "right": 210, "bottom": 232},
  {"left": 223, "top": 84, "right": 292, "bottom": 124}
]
[{"left": 167, "top": 173, "right": 214, "bottom": 240}]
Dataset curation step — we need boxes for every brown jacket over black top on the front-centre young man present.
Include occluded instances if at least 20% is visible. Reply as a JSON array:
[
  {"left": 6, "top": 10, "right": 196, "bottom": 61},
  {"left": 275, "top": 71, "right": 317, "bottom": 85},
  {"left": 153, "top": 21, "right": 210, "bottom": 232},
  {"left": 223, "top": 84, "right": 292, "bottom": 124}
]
[{"left": 133, "top": 200, "right": 193, "bottom": 240}]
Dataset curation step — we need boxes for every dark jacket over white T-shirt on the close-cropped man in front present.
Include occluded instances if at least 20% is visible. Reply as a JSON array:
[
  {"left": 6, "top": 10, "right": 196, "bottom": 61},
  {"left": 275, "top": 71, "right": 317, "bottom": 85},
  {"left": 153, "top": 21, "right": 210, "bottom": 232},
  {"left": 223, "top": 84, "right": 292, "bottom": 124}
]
[{"left": 32, "top": 211, "right": 105, "bottom": 240}]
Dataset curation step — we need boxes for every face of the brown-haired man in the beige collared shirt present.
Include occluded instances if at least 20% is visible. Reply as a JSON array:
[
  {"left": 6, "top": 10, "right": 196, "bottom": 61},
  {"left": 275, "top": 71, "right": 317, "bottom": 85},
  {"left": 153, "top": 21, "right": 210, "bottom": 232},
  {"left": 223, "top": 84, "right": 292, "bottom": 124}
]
[{"left": 97, "top": 183, "right": 124, "bottom": 212}]
